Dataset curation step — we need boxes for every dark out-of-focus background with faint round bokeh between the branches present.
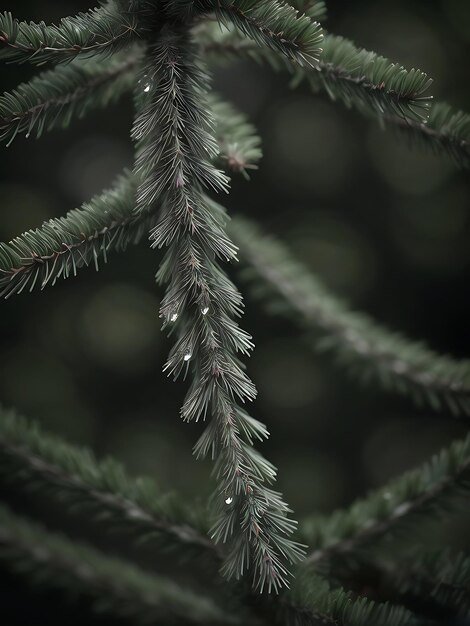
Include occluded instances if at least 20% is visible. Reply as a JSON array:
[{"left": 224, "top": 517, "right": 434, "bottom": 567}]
[{"left": 0, "top": 0, "right": 470, "bottom": 620}]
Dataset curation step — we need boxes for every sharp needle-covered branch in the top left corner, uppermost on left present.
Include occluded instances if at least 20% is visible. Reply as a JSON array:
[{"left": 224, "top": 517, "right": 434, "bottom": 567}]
[{"left": 0, "top": 1, "right": 137, "bottom": 65}]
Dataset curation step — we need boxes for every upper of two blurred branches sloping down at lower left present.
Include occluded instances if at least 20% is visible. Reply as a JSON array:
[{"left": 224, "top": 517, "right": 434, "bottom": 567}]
[{"left": 0, "top": 409, "right": 220, "bottom": 560}]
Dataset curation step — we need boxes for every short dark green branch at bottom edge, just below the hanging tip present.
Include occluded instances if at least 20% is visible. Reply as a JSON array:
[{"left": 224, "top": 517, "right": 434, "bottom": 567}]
[{"left": 276, "top": 571, "right": 418, "bottom": 626}]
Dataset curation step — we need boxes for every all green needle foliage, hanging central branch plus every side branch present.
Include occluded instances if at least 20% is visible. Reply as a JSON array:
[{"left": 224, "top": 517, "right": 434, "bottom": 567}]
[{"left": 0, "top": 0, "right": 470, "bottom": 626}]
